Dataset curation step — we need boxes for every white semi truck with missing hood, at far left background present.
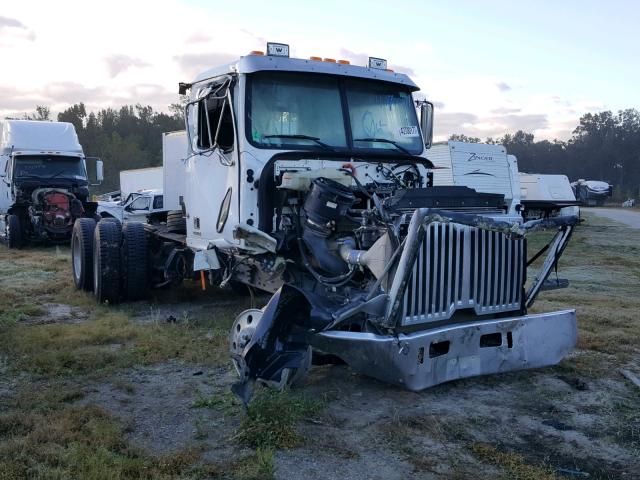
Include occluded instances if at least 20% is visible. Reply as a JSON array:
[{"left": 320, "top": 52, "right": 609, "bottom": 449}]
[{"left": 0, "top": 120, "right": 103, "bottom": 248}]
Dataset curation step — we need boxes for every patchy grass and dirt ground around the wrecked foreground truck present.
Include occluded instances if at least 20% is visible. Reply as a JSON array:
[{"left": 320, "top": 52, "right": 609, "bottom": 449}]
[{"left": 0, "top": 214, "right": 640, "bottom": 479}]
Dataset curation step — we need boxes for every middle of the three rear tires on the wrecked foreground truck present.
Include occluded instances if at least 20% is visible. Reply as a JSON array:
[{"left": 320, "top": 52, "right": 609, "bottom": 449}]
[{"left": 93, "top": 221, "right": 122, "bottom": 303}]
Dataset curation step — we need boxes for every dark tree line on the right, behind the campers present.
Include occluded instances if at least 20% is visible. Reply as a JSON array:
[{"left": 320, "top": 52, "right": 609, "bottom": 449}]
[{"left": 449, "top": 108, "right": 640, "bottom": 199}]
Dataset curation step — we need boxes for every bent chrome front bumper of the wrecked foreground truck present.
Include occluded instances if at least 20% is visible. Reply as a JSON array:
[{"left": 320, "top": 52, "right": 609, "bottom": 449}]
[{"left": 312, "top": 310, "right": 578, "bottom": 390}]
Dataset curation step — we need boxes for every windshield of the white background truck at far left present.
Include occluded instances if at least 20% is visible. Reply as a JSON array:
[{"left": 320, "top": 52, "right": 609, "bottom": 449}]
[{"left": 13, "top": 155, "right": 87, "bottom": 180}]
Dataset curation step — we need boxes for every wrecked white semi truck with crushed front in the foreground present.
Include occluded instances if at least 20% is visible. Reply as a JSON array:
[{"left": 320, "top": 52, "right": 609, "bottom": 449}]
[{"left": 72, "top": 44, "right": 578, "bottom": 400}]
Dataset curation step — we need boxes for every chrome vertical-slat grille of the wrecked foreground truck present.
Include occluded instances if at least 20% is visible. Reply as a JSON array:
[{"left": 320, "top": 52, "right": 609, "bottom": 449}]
[{"left": 400, "top": 223, "right": 525, "bottom": 325}]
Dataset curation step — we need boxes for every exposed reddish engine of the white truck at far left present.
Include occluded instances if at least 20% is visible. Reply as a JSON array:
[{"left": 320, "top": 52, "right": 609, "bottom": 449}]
[{"left": 28, "top": 188, "right": 84, "bottom": 239}]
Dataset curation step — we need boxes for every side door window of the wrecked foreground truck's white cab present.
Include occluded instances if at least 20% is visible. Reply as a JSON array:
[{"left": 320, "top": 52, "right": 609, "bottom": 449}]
[{"left": 198, "top": 87, "right": 234, "bottom": 152}]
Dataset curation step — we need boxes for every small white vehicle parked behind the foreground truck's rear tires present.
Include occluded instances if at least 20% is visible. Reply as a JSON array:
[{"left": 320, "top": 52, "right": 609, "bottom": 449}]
[{"left": 98, "top": 190, "right": 167, "bottom": 223}]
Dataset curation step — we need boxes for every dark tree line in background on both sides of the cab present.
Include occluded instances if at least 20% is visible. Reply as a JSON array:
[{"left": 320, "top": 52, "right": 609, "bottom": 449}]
[{"left": 7, "top": 103, "right": 640, "bottom": 199}]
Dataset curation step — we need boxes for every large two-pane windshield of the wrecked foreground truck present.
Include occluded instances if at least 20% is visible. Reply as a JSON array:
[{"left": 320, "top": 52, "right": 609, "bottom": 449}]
[{"left": 247, "top": 72, "right": 422, "bottom": 154}]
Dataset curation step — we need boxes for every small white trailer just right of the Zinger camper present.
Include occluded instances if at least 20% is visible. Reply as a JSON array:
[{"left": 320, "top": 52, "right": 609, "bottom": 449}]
[{"left": 520, "top": 172, "right": 580, "bottom": 220}]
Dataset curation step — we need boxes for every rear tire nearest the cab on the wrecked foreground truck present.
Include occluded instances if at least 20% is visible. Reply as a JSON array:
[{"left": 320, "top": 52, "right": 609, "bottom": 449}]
[{"left": 121, "top": 222, "right": 149, "bottom": 301}]
